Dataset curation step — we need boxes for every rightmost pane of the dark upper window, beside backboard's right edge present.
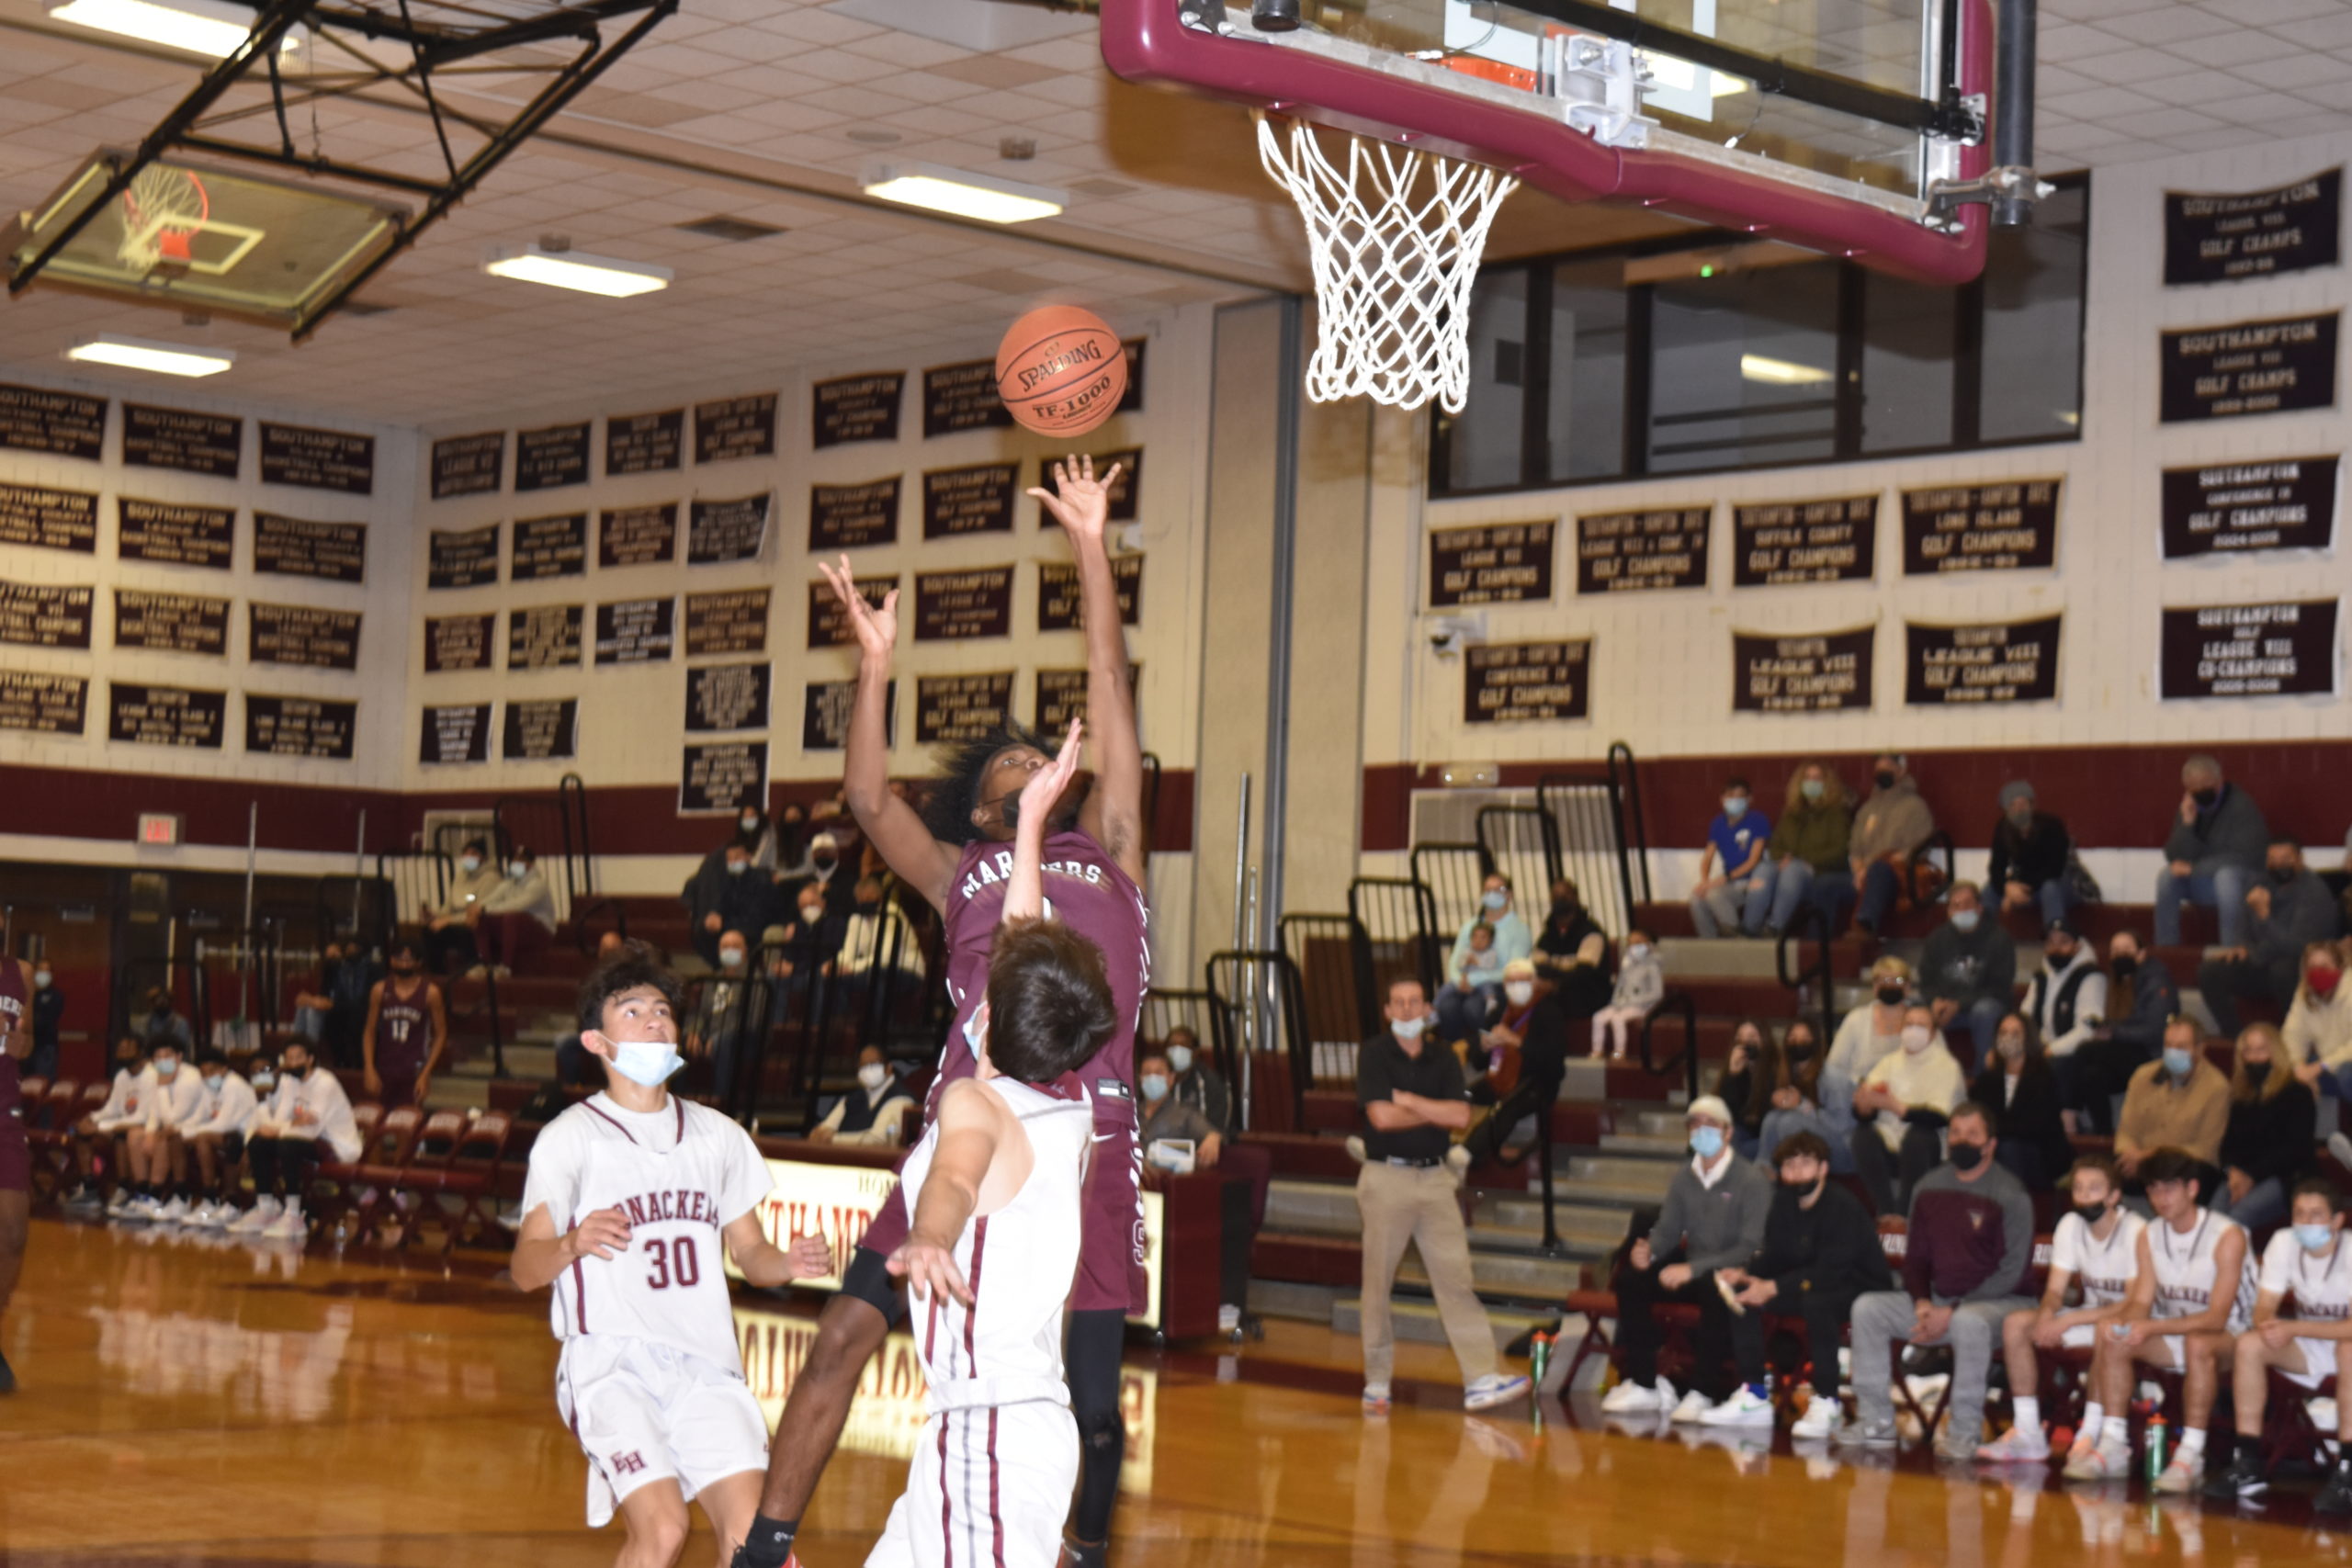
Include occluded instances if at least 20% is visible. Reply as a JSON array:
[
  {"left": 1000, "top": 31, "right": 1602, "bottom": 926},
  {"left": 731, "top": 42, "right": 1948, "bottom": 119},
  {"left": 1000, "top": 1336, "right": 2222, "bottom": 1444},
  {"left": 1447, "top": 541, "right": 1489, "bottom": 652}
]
[{"left": 1978, "top": 186, "right": 2084, "bottom": 442}]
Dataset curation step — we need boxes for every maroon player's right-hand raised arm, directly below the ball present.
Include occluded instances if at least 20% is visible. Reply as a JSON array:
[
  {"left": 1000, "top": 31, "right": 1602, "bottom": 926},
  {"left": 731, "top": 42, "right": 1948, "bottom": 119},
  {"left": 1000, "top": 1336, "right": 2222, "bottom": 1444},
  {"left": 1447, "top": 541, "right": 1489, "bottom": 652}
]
[{"left": 1030, "top": 456, "right": 1143, "bottom": 884}]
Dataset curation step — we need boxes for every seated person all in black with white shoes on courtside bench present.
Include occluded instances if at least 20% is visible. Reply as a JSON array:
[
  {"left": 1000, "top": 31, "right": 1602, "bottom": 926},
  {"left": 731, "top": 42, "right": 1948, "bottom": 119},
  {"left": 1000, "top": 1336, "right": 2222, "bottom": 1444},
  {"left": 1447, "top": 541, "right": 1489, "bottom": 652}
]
[{"left": 1701, "top": 1134, "right": 1895, "bottom": 1438}]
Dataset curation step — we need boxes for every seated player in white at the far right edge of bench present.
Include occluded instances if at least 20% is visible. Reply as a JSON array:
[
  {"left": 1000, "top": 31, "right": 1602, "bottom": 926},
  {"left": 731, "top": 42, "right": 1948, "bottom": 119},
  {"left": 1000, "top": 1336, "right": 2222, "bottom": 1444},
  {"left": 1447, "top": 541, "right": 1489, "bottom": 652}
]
[{"left": 2206, "top": 1180, "right": 2352, "bottom": 1514}]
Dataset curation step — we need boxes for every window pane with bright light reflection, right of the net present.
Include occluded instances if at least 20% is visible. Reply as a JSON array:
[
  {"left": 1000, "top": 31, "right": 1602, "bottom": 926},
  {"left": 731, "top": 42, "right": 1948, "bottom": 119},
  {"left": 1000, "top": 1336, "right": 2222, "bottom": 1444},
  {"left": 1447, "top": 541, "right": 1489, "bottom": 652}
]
[{"left": 1649, "top": 261, "right": 1837, "bottom": 472}]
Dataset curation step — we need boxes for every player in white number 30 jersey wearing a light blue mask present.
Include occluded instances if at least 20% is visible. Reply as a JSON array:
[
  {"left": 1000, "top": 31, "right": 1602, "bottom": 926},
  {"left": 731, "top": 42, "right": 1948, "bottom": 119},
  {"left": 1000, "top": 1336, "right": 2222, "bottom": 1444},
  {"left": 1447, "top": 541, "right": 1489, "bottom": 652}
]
[{"left": 511, "top": 942, "right": 832, "bottom": 1568}]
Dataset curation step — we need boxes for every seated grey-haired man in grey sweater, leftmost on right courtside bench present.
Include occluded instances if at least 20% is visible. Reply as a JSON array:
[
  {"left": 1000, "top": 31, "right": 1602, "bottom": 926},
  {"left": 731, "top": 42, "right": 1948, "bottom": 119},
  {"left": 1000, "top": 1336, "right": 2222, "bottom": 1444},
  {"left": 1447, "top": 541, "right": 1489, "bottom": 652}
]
[{"left": 1601, "top": 1096, "right": 1771, "bottom": 1425}]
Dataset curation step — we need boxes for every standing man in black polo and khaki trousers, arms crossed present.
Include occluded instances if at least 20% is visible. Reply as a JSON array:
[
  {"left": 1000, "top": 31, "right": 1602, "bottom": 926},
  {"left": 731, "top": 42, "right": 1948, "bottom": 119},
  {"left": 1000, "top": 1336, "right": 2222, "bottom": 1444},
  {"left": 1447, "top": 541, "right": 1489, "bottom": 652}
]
[{"left": 1355, "top": 978, "right": 1526, "bottom": 1416}]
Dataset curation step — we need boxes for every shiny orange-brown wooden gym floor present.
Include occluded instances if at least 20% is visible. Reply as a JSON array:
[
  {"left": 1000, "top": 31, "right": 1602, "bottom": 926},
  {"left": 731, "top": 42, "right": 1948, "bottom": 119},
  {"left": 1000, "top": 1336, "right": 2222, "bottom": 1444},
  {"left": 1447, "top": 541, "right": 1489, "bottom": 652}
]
[{"left": 14, "top": 1220, "right": 2352, "bottom": 1568}]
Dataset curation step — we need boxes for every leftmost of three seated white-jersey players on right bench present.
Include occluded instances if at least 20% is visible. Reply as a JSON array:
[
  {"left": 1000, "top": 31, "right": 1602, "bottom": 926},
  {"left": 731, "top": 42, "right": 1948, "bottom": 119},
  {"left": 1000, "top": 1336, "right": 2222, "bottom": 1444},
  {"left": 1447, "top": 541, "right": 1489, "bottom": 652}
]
[{"left": 1975, "top": 1156, "right": 2147, "bottom": 1464}]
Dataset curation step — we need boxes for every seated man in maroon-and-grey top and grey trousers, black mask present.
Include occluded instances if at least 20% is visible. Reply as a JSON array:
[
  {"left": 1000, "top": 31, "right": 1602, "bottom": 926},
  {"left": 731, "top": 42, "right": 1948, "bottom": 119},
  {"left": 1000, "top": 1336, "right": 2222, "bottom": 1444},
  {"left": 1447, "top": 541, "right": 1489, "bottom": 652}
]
[{"left": 1837, "top": 1100, "right": 2034, "bottom": 1460}]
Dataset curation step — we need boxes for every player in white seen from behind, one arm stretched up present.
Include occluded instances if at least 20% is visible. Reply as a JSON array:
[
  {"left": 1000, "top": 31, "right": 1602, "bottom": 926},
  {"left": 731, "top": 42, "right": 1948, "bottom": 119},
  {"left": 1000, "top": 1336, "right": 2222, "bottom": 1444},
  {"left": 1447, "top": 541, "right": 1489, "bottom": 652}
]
[{"left": 865, "top": 724, "right": 1120, "bottom": 1568}]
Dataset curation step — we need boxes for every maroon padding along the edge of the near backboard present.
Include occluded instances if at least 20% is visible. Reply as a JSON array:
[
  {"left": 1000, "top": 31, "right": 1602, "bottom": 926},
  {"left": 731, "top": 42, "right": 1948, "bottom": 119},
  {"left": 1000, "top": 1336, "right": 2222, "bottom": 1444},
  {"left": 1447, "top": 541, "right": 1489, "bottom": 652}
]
[{"left": 1101, "top": 0, "right": 1992, "bottom": 285}]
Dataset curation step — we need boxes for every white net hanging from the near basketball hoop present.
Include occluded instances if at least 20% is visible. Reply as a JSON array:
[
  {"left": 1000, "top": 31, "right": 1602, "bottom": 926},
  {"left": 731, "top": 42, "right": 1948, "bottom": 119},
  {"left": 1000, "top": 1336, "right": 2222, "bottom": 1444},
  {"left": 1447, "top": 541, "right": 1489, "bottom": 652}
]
[{"left": 1259, "top": 113, "right": 1520, "bottom": 413}]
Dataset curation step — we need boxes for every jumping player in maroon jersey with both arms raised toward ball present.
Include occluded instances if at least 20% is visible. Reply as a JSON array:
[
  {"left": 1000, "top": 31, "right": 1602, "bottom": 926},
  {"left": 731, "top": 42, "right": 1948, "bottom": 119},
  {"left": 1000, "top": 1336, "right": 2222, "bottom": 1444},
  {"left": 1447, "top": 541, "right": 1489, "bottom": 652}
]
[{"left": 734, "top": 458, "right": 1150, "bottom": 1568}]
